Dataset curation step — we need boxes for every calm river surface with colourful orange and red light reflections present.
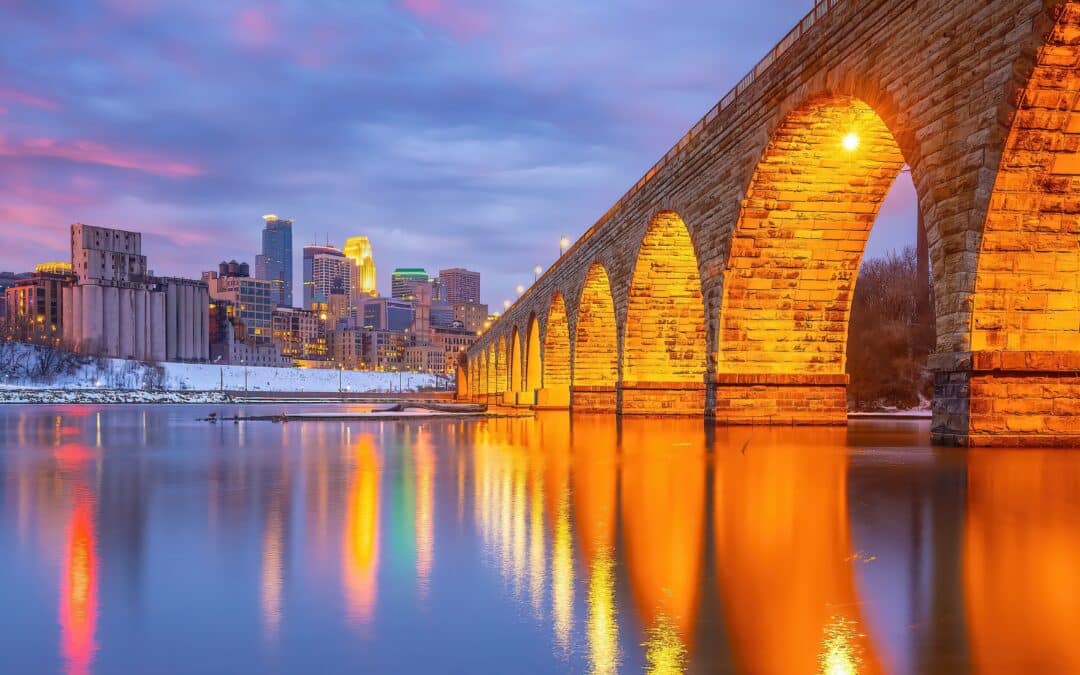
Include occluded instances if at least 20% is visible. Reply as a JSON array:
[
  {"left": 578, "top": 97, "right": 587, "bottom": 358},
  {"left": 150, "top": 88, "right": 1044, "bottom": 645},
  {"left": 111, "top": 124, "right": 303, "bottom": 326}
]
[{"left": 0, "top": 406, "right": 1080, "bottom": 675}]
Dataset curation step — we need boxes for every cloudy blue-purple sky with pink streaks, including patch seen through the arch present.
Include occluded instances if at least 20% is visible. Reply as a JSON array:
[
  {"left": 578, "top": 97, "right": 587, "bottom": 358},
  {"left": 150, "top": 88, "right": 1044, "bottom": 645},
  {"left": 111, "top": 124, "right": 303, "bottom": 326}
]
[{"left": 0, "top": 0, "right": 915, "bottom": 309}]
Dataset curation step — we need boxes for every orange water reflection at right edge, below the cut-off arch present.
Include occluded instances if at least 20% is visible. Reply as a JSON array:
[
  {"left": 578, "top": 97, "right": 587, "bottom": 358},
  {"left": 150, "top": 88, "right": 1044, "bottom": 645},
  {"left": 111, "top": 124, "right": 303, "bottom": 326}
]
[{"left": 963, "top": 449, "right": 1080, "bottom": 673}]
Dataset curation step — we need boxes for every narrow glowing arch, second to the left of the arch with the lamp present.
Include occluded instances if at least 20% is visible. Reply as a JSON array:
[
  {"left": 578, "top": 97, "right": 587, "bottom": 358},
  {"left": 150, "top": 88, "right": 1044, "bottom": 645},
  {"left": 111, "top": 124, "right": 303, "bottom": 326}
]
[{"left": 572, "top": 262, "right": 619, "bottom": 413}]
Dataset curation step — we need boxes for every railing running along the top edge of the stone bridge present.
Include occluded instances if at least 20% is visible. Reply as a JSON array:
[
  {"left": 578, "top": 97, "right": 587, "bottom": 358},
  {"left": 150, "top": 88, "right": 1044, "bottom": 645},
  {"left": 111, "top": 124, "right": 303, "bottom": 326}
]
[{"left": 486, "top": 0, "right": 846, "bottom": 339}]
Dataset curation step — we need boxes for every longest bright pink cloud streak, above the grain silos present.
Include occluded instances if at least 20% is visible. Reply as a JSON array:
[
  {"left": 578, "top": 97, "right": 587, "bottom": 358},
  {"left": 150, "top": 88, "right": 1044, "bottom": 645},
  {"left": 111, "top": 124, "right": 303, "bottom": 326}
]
[{"left": 0, "top": 135, "right": 206, "bottom": 178}]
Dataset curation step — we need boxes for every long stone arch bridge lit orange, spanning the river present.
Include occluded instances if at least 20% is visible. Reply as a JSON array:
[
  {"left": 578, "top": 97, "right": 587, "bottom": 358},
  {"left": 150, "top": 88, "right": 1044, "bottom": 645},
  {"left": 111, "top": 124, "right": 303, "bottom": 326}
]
[{"left": 459, "top": 0, "right": 1080, "bottom": 445}]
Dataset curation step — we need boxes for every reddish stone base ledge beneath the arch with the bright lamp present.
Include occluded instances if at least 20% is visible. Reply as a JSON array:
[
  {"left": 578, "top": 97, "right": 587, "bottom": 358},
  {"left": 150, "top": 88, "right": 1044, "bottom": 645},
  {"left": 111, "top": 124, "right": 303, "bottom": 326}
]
[{"left": 715, "top": 373, "right": 848, "bottom": 424}]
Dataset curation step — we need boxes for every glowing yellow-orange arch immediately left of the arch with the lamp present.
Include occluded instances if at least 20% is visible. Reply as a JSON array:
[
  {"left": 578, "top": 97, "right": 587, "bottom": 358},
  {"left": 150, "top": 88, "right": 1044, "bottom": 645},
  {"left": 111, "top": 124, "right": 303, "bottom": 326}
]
[{"left": 622, "top": 211, "right": 708, "bottom": 415}]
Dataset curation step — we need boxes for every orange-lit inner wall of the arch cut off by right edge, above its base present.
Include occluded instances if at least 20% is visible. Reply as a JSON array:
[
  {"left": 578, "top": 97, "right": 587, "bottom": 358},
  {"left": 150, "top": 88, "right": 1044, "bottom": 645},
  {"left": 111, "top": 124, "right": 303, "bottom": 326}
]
[{"left": 971, "top": 13, "right": 1080, "bottom": 351}]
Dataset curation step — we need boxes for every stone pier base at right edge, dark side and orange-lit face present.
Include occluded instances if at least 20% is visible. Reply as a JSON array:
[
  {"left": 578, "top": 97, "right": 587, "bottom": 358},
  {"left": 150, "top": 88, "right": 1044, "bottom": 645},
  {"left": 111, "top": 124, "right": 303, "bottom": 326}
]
[{"left": 930, "top": 351, "right": 1080, "bottom": 447}]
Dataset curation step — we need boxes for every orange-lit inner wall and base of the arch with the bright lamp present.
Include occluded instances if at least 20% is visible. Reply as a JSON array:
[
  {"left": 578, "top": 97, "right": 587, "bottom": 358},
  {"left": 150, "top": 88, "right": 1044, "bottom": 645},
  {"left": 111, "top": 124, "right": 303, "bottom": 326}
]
[{"left": 716, "top": 95, "right": 905, "bottom": 423}]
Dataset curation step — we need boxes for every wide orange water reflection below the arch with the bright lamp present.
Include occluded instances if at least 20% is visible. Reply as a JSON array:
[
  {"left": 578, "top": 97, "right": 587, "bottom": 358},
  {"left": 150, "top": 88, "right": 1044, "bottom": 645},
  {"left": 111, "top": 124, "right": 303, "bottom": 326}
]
[{"left": 713, "top": 429, "right": 879, "bottom": 674}]
